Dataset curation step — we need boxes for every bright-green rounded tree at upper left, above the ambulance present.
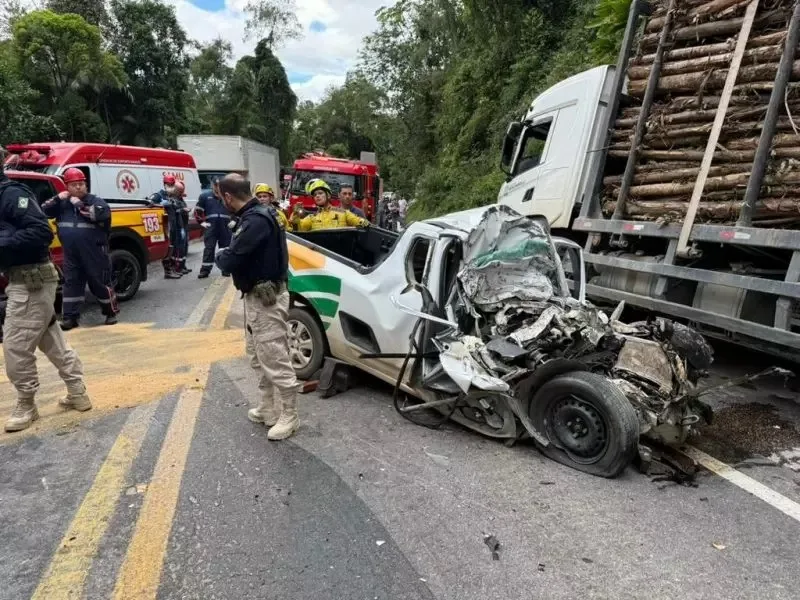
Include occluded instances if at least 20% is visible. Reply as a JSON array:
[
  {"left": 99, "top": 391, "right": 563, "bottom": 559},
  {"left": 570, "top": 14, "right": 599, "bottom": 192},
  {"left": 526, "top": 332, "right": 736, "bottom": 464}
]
[{"left": 13, "top": 10, "right": 125, "bottom": 140}]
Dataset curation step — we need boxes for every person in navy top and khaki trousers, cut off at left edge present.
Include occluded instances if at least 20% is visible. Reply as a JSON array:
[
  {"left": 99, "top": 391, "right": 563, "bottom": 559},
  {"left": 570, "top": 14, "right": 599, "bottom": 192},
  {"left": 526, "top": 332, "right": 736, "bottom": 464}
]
[{"left": 0, "top": 159, "right": 92, "bottom": 431}]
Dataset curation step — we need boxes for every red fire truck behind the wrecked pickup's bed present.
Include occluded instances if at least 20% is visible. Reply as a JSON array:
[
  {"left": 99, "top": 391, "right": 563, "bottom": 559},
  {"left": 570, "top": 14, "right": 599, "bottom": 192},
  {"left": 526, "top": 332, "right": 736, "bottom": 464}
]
[{"left": 289, "top": 153, "right": 383, "bottom": 223}]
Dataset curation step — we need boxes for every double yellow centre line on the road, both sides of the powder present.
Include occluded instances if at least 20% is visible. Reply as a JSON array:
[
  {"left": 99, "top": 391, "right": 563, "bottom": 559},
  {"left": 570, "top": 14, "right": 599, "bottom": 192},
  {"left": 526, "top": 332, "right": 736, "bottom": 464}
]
[{"left": 32, "top": 280, "right": 235, "bottom": 600}]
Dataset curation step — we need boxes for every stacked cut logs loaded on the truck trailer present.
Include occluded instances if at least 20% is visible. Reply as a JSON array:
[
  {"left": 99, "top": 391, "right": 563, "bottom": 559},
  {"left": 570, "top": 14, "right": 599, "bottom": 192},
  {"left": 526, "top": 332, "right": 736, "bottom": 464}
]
[{"left": 603, "top": 0, "right": 800, "bottom": 227}]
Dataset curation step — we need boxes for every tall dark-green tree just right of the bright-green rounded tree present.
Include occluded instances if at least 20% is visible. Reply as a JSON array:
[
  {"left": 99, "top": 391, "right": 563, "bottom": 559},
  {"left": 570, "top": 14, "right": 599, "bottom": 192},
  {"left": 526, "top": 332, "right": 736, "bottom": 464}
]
[{"left": 106, "top": 0, "right": 189, "bottom": 146}]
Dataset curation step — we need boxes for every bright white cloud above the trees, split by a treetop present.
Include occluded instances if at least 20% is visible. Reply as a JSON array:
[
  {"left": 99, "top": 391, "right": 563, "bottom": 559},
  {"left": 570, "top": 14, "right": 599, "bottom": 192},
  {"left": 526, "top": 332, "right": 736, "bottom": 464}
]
[{"left": 167, "top": 0, "right": 393, "bottom": 100}]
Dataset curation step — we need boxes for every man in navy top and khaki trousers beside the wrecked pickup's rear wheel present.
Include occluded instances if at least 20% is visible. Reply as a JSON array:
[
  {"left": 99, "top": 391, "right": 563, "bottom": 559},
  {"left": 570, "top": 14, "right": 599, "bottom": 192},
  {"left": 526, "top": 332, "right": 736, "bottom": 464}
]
[{"left": 216, "top": 173, "right": 300, "bottom": 440}]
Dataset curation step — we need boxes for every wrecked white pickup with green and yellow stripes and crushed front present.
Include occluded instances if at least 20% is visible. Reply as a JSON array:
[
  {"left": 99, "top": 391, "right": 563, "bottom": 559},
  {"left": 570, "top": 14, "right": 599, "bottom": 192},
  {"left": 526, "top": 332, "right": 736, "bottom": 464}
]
[{"left": 287, "top": 205, "right": 712, "bottom": 477}]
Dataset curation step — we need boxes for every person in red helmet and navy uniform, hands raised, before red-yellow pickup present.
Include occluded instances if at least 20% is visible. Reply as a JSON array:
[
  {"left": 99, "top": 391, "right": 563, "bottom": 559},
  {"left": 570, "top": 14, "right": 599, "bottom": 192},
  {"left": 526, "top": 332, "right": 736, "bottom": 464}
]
[{"left": 42, "top": 167, "right": 119, "bottom": 331}]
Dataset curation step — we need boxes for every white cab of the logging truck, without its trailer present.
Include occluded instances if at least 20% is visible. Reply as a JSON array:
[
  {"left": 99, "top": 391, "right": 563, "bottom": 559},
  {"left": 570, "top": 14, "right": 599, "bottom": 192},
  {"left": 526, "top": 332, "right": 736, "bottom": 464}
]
[{"left": 498, "top": 66, "right": 615, "bottom": 229}]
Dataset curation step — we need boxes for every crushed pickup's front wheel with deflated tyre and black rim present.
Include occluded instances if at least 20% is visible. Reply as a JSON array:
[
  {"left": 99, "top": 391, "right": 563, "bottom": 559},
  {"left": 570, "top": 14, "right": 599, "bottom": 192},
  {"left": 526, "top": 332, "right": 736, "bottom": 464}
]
[{"left": 528, "top": 371, "right": 639, "bottom": 477}]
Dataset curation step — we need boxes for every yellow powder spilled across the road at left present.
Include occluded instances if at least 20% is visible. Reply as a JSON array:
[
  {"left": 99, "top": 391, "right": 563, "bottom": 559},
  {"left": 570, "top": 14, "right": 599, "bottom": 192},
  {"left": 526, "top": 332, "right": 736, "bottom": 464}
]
[{"left": 0, "top": 323, "right": 244, "bottom": 444}]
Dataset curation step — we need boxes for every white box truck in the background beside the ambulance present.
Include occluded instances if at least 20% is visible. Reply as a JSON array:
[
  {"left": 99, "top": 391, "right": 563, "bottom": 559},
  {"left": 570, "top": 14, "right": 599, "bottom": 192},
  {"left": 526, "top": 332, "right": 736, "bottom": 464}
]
[{"left": 178, "top": 135, "right": 281, "bottom": 194}]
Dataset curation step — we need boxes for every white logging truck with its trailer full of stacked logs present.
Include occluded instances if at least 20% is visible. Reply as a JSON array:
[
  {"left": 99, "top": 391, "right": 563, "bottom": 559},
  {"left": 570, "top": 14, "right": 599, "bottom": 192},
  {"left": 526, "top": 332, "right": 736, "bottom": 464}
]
[{"left": 498, "top": 0, "right": 800, "bottom": 360}]
